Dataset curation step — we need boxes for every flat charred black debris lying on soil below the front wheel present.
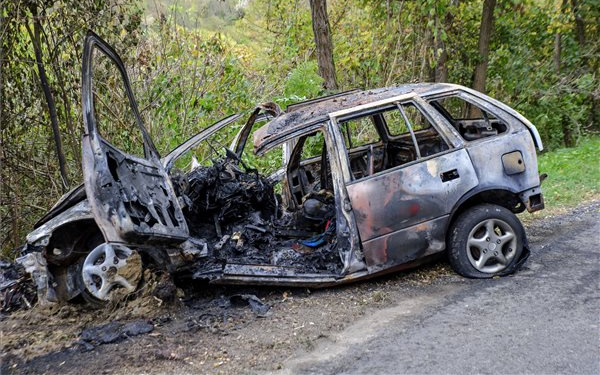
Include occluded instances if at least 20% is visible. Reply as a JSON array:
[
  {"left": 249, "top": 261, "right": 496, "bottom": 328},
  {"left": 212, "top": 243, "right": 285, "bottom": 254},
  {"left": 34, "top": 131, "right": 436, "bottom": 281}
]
[{"left": 78, "top": 320, "right": 154, "bottom": 351}]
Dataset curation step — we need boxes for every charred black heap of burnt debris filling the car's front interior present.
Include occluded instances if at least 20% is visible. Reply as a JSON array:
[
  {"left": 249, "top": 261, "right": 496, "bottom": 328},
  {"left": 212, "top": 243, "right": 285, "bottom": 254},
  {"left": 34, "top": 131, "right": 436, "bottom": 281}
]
[{"left": 176, "top": 158, "right": 341, "bottom": 279}]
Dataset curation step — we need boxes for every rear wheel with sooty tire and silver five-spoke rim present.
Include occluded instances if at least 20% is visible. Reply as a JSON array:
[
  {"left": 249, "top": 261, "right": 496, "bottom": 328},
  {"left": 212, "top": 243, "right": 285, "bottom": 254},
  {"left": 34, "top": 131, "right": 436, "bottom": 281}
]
[{"left": 448, "top": 204, "right": 526, "bottom": 278}]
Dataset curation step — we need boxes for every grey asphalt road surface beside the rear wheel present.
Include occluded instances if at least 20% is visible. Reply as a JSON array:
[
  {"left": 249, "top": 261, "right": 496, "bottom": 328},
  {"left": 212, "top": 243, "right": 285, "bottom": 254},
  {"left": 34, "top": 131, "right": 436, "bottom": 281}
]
[{"left": 281, "top": 203, "right": 600, "bottom": 374}]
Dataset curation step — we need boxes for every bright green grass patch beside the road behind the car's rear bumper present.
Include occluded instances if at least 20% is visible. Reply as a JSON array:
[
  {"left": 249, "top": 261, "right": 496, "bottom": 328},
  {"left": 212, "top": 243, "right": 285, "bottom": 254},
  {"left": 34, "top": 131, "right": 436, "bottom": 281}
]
[{"left": 538, "top": 136, "right": 600, "bottom": 211}]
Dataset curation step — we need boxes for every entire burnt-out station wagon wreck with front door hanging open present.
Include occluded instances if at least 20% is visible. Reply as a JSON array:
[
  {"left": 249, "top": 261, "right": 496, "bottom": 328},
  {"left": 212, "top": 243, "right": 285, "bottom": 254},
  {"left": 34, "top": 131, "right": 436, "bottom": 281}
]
[{"left": 19, "top": 33, "right": 544, "bottom": 305}]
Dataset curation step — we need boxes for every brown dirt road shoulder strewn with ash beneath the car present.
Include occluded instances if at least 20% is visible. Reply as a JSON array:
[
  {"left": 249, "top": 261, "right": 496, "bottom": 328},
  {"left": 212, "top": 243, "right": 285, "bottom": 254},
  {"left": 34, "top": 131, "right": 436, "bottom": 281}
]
[{"left": 0, "top": 201, "right": 600, "bottom": 374}]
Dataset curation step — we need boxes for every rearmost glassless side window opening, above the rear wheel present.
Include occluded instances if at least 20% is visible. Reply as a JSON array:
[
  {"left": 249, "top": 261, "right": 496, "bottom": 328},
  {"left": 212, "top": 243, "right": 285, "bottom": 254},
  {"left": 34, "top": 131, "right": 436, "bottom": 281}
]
[{"left": 430, "top": 95, "right": 508, "bottom": 141}]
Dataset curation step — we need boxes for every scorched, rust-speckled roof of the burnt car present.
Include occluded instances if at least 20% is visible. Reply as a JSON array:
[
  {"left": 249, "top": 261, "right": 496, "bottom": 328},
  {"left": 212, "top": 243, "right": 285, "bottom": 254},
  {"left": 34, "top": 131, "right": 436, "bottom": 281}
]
[{"left": 254, "top": 83, "right": 462, "bottom": 154}]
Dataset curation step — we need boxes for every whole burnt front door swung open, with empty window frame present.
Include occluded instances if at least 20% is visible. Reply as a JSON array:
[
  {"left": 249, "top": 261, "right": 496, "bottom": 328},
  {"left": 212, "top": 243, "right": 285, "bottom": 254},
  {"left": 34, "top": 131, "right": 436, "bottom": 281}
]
[{"left": 82, "top": 32, "right": 189, "bottom": 245}]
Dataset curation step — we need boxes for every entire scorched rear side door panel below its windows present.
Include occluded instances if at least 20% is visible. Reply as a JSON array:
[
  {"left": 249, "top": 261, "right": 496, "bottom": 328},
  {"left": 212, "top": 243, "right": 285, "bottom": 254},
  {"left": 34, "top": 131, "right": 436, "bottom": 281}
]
[{"left": 347, "top": 149, "right": 478, "bottom": 268}]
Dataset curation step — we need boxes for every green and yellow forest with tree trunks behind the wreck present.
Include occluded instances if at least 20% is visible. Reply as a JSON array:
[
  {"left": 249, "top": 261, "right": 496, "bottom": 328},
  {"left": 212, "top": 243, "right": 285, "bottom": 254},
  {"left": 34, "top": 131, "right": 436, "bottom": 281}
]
[{"left": 0, "top": 0, "right": 600, "bottom": 257}]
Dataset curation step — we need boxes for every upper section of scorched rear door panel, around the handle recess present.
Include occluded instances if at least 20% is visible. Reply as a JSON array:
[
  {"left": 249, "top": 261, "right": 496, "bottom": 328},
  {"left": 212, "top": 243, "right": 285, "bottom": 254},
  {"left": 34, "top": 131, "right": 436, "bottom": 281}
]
[{"left": 347, "top": 149, "right": 478, "bottom": 242}]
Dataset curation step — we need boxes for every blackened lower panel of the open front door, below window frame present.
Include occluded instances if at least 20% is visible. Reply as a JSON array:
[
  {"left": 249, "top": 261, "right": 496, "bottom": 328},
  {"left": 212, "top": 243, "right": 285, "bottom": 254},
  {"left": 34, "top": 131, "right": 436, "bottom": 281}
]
[{"left": 82, "top": 135, "right": 188, "bottom": 244}]
